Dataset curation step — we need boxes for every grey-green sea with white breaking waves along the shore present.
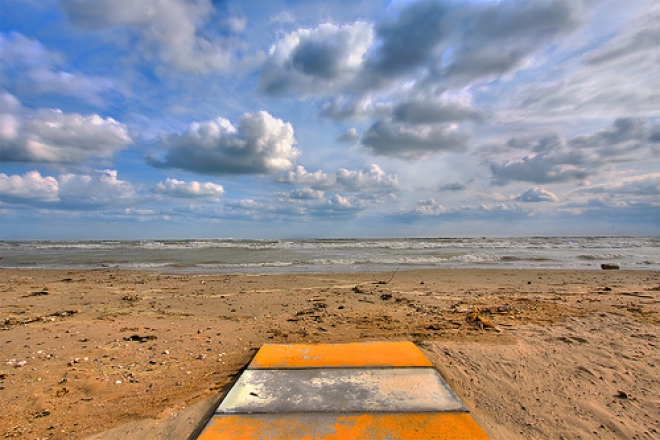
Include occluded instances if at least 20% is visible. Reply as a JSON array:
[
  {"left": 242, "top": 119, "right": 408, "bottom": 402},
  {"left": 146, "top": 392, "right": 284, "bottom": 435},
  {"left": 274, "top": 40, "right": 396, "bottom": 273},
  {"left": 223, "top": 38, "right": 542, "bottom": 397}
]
[{"left": 0, "top": 237, "right": 660, "bottom": 273}]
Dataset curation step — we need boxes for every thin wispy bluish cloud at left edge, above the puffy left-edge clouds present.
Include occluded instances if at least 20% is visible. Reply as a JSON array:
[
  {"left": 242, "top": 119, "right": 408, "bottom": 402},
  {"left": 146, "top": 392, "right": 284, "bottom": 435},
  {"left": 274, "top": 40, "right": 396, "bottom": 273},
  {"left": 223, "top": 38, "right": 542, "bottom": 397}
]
[{"left": 0, "top": 32, "right": 114, "bottom": 105}]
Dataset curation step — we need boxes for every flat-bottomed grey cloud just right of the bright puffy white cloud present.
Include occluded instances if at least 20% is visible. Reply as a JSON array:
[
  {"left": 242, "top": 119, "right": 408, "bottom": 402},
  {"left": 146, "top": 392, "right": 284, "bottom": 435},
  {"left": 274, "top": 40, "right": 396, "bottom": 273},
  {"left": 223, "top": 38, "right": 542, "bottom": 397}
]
[{"left": 361, "top": 120, "right": 468, "bottom": 159}]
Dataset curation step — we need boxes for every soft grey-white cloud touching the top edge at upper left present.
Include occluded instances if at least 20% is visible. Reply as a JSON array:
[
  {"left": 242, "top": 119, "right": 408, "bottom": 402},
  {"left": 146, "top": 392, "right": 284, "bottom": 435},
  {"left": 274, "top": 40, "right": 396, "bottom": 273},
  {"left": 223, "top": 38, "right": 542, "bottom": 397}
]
[{"left": 61, "top": 0, "right": 245, "bottom": 73}]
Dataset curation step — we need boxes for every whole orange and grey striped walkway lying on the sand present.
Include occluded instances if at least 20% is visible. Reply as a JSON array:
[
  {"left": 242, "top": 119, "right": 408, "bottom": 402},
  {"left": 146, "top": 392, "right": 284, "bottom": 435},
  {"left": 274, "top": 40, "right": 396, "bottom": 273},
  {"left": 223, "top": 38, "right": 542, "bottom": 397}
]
[{"left": 198, "top": 342, "right": 488, "bottom": 440}]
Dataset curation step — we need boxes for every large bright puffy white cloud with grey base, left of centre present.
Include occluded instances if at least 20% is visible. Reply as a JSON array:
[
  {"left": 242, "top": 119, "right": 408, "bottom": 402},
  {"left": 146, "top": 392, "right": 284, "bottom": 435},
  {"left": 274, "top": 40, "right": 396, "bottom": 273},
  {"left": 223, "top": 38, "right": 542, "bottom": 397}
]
[{"left": 147, "top": 111, "right": 299, "bottom": 175}]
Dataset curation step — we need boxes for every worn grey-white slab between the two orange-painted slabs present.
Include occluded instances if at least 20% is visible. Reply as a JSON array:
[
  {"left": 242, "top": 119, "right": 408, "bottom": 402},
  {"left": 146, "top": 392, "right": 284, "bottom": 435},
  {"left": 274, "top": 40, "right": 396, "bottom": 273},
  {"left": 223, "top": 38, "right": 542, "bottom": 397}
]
[{"left": 217, "top": 368, "right": 468, "bottom": 413}]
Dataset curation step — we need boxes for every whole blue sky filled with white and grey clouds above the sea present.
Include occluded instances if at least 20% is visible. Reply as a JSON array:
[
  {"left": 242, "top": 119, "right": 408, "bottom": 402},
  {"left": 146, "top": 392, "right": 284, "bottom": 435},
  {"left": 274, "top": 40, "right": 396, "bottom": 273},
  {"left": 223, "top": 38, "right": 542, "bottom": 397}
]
[{"left": 0, "top": 0, "right": 660, "bottom": 240}]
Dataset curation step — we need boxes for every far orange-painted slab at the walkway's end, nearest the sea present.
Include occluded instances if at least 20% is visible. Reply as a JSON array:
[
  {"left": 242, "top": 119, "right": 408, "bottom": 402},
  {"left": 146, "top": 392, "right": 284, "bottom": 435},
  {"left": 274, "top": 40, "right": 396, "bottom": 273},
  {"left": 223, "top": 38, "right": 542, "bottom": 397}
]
[{"left": 248, "top": 341, "right": 432, "bottom": 370}]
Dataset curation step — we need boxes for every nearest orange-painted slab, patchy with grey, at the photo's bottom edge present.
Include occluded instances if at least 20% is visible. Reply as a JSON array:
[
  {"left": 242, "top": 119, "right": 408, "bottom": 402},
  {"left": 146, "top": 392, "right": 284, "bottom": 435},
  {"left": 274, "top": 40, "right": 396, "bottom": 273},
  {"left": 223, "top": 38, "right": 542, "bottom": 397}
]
[{"left": 198, "top": 413, "right": 488, "bottom": 440}]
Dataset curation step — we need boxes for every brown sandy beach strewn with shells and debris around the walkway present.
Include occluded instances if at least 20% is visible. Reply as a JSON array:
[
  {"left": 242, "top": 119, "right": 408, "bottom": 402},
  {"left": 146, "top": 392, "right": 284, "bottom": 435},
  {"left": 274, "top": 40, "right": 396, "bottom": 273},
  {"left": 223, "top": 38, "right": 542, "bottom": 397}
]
[{"left": 0, "top": 270, "right": 660, "bottom": 440}]
